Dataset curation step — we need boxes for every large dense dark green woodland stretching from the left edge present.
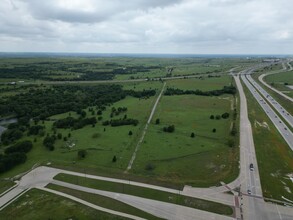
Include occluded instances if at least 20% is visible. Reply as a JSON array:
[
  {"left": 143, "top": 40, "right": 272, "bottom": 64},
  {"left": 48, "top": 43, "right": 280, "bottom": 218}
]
[{"left": 0, "top": 85, "right": 127, "bottom": 123}]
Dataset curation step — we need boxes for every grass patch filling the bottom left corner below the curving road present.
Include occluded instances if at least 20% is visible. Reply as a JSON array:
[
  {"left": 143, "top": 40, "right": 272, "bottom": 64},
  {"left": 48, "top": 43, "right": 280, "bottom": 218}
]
[{"left": 0, "top": 189, "right": 128, "bottom": 220}]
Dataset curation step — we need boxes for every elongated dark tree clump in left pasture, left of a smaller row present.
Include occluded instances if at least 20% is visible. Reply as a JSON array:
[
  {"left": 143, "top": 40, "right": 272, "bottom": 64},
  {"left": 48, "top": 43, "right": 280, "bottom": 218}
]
[{"left": 53, "top": 117, "right": 97, "bottom": 130}]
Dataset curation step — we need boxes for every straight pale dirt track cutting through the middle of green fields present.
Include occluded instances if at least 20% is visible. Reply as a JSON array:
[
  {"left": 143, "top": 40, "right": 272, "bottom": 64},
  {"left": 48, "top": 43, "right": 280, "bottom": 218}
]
[{"left": 126, "top": 82, "right": 166, "bottom": 171}]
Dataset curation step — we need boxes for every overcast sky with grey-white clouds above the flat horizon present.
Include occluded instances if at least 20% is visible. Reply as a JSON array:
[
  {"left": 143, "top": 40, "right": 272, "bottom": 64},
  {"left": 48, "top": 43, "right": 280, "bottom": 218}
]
[{"left": 0, "top": 0, "right": 293, "bottom": 54}]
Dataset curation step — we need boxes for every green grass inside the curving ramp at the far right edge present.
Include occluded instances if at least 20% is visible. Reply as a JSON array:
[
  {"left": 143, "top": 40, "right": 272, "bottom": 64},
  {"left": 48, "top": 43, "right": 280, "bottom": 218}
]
[{"left": 264, "top": 71, "right": 293, "bottom": 97}]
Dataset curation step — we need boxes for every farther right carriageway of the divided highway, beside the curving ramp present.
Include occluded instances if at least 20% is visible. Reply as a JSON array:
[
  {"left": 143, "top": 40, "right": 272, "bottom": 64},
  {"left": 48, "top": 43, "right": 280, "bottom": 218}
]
[{"left": 246, "top": 75, "right": 293, "bottom": 128}]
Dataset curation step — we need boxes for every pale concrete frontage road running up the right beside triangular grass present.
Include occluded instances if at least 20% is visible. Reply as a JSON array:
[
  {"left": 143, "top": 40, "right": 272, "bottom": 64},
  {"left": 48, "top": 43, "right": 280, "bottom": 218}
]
[{"left": 234, "top": 69, "right": 293, "bottom": 220}]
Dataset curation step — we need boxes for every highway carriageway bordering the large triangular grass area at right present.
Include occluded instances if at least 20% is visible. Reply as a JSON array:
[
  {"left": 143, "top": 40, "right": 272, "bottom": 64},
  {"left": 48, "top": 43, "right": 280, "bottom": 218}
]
[{"left": 241, "top": 74, "right": 293, "bottom": 150}]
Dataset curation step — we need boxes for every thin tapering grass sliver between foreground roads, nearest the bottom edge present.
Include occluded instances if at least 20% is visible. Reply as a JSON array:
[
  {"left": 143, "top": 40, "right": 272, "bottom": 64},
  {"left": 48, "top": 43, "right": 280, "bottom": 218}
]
[{"left": 46, "top": 184, "right": 161, "bottom": 220}]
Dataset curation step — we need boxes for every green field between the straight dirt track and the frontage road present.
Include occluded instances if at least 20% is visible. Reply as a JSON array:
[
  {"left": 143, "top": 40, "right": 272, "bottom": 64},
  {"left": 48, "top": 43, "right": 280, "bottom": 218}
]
[{"left": 131, "top": 95, "right": 238, "bottom": 186}]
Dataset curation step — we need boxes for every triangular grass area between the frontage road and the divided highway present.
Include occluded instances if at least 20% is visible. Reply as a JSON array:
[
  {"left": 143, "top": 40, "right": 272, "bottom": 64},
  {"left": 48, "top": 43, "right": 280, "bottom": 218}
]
[{"left": 243, "top": 80, "right": 293, "bottom": 200}]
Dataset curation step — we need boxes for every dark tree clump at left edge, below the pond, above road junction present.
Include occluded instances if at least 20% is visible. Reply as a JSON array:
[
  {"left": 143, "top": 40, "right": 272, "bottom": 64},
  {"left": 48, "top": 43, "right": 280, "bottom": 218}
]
[{"left": 0, "top": 141, "right": 33, "bottom": 173}]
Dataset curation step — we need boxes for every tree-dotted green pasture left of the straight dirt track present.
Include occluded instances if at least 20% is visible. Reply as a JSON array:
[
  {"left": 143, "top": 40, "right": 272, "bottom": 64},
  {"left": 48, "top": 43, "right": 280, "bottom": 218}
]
[{"left": 1, "top": 94, "right": 156, "bottom": 177}]
